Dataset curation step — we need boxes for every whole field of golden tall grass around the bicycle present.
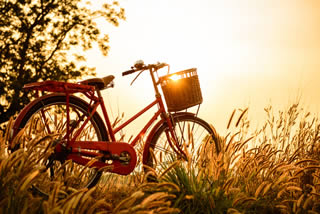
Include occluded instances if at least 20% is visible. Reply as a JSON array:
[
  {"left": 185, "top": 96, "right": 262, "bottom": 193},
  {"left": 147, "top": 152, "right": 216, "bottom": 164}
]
[{"left": 0, "top": 104, "right": 320, "bottom": 214}]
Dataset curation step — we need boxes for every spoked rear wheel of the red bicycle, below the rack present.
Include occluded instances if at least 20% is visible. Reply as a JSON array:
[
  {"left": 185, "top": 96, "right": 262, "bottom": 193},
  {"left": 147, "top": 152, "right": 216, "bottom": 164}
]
[{"left": 14, "top": 95, "right": 108, "bottom": 196}]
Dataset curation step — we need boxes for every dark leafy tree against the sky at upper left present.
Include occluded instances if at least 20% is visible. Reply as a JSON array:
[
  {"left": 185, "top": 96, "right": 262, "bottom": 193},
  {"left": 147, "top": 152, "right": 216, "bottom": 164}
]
[{"left": 0, "top": 0, "right": 125, "bottom": 123}]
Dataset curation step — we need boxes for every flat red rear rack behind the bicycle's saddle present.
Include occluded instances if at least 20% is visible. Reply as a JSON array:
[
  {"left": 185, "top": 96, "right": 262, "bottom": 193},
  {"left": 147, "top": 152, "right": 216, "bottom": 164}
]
[{"left": 23, "top": 80, "right": 95, "bottom": 93}]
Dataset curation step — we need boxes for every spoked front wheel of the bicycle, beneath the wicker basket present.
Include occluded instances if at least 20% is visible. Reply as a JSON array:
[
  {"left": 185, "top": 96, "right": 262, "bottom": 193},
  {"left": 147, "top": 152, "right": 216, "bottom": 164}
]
[{"left": 145, "top": 114, "right": 220, "bottom": 174}]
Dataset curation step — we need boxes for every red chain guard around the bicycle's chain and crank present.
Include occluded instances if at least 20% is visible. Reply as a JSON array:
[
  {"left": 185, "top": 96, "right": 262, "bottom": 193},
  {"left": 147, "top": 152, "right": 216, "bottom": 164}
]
[{"left": 67, "top": 141, "right": 137, "bottom": 175}]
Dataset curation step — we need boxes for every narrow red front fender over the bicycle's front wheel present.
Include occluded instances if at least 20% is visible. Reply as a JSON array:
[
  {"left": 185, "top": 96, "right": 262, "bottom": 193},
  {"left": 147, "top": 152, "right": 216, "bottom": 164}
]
[{"left": 142, "top": 112, "right": 195, "bottom": 164}]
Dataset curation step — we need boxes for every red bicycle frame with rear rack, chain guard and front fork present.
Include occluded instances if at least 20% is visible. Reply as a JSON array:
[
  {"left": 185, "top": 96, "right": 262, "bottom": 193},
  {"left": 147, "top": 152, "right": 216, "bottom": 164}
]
[{"left": 12, "top": 71, "right": 185, "bottom": 175}]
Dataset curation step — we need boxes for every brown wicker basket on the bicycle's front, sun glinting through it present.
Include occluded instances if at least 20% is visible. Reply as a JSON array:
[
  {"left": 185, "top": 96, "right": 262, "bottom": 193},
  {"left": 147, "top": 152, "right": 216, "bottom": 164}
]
[{"left": 159, "top": 68, "right": 202, "bottom": 112}]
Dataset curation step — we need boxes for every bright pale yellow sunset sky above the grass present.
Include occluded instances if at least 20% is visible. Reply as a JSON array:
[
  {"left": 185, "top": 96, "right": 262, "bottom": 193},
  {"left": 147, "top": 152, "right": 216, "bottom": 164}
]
[{"left": 88, "top": 0, "right": 320, "bottom": 132}]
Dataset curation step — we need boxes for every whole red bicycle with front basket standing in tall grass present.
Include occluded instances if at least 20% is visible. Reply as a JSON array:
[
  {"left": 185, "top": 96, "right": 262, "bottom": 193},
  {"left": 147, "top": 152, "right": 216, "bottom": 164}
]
[{"left": 10, "top": 61, "right": 219, "bottom": 194}]
